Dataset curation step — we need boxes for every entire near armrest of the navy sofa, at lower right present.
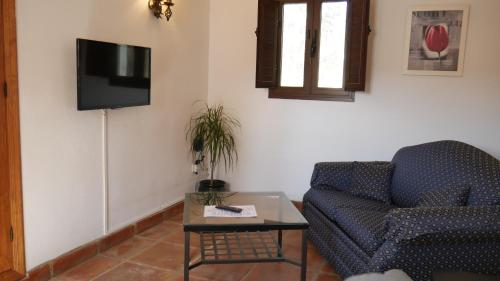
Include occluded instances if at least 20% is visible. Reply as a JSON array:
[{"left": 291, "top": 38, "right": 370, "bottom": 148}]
[{"left": 369, "top": 206, "right": 500, "bottom": 280}]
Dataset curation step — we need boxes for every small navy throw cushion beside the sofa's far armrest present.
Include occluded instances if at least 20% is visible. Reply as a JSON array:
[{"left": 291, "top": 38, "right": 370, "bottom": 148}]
[{"left": 347, "top": 162, "right": 394, "bottom": 204}]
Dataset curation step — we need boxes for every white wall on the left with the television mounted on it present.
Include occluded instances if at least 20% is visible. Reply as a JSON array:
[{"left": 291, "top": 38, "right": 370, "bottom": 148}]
[{"left": 17, "top": 0, "right": 208, "bottom": 269}]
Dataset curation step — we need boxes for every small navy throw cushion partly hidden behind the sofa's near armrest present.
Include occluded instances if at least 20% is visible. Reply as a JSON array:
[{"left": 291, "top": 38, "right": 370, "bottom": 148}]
[{"left": 418, "top": 186, "right": 470, "bottom": 207}]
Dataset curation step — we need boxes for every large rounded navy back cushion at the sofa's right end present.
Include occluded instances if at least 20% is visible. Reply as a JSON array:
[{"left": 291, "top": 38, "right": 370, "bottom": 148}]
[{"left": 391, "top": 141, "right": 500, "bottom": 207}]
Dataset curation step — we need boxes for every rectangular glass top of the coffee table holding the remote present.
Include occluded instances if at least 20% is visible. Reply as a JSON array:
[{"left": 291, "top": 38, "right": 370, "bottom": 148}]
[{"left": 184, "top": 192, "right": 309, "bottom": 231}]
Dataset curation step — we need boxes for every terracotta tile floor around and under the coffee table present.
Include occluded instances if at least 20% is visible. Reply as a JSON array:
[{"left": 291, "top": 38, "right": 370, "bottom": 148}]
[{"left": 52, "top": 213, "right": 341, "bottom": 281}]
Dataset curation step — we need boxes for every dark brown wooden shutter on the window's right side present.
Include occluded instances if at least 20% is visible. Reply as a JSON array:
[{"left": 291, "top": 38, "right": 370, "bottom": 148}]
[{"left": 344, "top": 0, "right": 370, "bottom": 92}]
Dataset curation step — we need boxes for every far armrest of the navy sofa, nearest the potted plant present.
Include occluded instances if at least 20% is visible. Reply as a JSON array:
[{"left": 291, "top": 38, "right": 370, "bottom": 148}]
[{"left": 311, "top": 162, "right": 354, "bottom": 190}]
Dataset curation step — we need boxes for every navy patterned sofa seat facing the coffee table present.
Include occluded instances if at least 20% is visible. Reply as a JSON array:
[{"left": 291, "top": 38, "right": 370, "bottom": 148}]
[{"left": 304, "top": 189, "right": 395, "bottom": 256}]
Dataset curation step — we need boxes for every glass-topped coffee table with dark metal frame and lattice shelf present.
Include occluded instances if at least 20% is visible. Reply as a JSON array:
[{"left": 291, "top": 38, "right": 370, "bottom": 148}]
[{"left": 184, "top": 192, "right": 309, "bottom": 281}]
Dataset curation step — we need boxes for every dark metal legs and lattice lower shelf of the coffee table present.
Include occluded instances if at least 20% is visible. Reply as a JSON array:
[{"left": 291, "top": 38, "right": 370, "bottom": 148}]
[{"left": 184, "top": 191, "right": 309, "bottom": 281}]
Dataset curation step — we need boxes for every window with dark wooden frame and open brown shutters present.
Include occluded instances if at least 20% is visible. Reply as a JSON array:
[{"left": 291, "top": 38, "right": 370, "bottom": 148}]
[{"left": 256, "top": 0, "right": 369, "bottom": 101}]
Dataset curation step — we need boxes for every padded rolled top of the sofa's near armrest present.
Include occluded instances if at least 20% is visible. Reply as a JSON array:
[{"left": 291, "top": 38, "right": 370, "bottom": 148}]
[{"left": 384, "top": 205, "right": 500, "bottom": 244}]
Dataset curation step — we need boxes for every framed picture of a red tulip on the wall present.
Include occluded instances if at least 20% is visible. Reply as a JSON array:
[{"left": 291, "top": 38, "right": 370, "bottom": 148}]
[{"left": 403, "top": 5, "right": 469, "bottom": 76}]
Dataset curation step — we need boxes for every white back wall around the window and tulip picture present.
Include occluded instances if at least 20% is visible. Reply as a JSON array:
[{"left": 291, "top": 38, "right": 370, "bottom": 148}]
[{"left": 209, "top": 0, "right": 500, "bottom": 199}]
